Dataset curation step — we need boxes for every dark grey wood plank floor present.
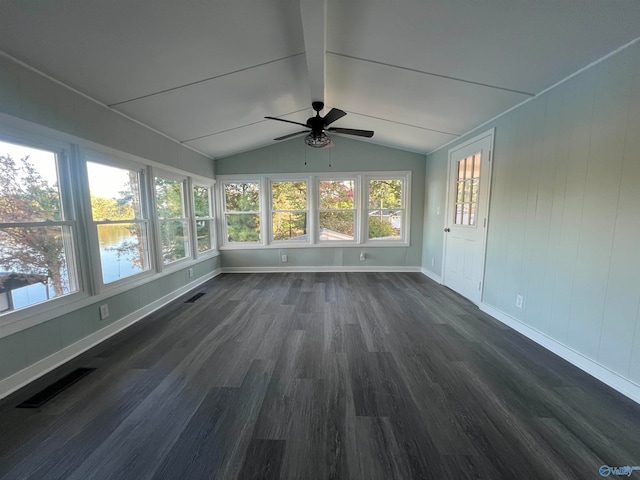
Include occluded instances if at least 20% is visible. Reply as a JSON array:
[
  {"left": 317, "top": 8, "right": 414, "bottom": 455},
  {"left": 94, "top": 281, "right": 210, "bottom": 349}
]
[{"left": 0, "top": 273, "right": 640, "bottom": 480}]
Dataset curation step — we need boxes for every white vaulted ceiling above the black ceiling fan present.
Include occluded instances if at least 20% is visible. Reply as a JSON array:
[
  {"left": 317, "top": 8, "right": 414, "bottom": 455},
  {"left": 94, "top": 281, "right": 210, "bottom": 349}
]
[{"left": 0, "top": 0, "right": 640, "bottom": 158}]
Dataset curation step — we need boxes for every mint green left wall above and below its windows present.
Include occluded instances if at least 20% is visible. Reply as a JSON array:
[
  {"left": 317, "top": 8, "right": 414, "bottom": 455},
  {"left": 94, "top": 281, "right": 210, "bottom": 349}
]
[{"left": 0, "top": 57, "right": 220, "bottom": 386}]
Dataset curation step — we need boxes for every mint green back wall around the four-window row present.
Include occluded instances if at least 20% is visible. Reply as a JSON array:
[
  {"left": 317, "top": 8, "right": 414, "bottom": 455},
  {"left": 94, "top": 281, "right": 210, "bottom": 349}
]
[{"left": 216, "top": 135, "right": 425, "bottom": 268}]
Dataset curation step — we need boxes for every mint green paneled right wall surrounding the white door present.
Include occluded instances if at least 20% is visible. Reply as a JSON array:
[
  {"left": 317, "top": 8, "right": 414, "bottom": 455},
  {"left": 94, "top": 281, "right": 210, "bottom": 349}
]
[{"left": 423, "top": 43, "right": 640, "bottom": 383}]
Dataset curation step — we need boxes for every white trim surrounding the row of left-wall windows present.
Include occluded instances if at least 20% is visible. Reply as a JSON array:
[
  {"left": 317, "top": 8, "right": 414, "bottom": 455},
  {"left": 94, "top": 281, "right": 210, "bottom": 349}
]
[{"left": 0, "top": 112, "right": 220, "bottom": 338}]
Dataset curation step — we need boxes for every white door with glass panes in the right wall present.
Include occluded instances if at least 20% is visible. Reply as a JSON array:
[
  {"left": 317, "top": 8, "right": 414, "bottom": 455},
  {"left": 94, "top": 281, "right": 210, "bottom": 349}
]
[{"left": 443, "top": 131, "right": 493, "bottom": 304}]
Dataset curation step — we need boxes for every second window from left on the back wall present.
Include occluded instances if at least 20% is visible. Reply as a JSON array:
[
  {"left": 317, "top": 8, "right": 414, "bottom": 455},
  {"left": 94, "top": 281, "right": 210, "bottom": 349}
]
[{"left": 271, "top": 180, "right": 308, "bottom": 242}]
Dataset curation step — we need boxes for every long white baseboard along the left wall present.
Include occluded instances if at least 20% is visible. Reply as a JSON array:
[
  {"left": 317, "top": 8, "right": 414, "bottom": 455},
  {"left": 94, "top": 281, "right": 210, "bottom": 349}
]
[{"left": 0, "top": 268, "right": 222, "bottom": 399}]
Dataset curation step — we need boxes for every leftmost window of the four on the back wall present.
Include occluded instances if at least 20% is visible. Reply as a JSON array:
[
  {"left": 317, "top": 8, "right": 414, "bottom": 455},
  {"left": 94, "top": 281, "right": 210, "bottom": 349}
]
[{"left": 224, "top": 182, "right": 260, "bottom": 243}]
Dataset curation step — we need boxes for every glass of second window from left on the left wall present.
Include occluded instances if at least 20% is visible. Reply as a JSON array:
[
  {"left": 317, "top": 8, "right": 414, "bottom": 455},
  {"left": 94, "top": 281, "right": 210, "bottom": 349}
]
[{"left": 87, "top": 162, "right": 151, "bottom": 284}]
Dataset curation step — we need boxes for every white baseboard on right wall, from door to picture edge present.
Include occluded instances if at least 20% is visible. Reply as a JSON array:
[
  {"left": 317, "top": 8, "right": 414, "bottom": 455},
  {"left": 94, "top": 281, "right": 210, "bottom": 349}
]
[{"left": 480, "top": 303, "right": 640, "bottom": 403}]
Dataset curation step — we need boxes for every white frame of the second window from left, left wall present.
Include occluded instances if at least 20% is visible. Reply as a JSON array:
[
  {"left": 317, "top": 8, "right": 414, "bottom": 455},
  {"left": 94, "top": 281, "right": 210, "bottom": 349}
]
[{"left": 81, "top": 149, "right": 157, "bottom": 293}]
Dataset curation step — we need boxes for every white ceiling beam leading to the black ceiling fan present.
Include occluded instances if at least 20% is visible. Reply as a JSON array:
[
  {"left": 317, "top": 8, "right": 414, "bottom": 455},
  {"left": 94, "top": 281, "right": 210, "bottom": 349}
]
[{"left": 300, "top": 0, "right": 327, "bottom": 107}]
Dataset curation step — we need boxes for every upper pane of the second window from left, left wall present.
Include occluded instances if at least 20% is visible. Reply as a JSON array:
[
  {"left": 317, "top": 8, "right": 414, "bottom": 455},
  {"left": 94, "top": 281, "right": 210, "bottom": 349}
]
[{"left": 87, "top": 162, "right": 142, "bottom": 221}]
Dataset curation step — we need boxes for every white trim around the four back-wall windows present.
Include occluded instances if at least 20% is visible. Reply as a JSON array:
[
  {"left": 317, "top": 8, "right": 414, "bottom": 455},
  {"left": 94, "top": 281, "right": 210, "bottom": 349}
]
[{"left": 216, "top": 170, "right": 412, "bottom": 250}]
